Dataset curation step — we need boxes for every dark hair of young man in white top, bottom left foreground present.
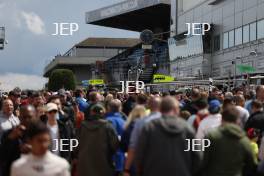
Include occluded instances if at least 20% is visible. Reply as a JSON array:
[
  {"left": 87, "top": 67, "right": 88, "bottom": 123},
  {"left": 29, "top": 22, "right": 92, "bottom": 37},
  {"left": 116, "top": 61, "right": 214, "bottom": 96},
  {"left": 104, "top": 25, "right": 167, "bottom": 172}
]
[{"left": 26, "top": 121, "right": 50, "bottom": 139}]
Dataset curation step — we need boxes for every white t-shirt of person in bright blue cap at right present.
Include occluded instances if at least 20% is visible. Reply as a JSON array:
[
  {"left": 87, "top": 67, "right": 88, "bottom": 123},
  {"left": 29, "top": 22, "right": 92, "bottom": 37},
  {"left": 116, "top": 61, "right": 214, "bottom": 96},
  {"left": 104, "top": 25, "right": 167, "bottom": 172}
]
[{"left": 196, "top": 114, "right": 222, "bottom": 139}]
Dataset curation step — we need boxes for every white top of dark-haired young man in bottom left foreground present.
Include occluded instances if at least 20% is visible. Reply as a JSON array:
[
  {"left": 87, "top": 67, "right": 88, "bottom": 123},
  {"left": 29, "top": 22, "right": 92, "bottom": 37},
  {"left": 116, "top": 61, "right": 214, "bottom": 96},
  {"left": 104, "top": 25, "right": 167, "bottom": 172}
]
[{"left": 11, "top": 151, "right": 70, "bottom": 176}]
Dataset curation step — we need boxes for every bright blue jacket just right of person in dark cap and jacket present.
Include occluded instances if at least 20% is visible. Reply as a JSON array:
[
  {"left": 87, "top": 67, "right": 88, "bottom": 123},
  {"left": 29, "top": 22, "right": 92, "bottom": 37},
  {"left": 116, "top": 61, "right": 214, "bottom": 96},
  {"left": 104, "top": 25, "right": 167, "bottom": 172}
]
[{"left": 105, "top": 112, "right": 125, "bottom": 171}]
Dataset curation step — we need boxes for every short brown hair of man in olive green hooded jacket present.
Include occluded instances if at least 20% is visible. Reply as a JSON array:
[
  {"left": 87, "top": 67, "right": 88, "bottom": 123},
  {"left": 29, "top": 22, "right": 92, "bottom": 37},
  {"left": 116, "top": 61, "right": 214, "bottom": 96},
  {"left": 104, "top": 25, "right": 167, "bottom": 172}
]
[{"left": 222, "top": 106, "right": 239, "bottom": 123}]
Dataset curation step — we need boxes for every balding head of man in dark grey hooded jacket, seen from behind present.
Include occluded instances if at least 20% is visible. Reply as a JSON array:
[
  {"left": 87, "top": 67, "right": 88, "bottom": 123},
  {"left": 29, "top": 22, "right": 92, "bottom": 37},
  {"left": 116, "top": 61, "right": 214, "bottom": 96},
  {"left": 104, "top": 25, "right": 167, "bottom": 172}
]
[{"left": 160, "top": 96, "right": 179, "bottom": 116}]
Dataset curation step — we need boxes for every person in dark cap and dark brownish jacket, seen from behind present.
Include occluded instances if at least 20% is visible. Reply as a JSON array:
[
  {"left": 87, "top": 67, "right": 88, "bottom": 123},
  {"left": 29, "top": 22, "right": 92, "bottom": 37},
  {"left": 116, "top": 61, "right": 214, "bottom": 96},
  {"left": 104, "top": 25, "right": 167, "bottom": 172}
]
[{"left": 77, "top": 104, "right": 119, "bottom": 176}]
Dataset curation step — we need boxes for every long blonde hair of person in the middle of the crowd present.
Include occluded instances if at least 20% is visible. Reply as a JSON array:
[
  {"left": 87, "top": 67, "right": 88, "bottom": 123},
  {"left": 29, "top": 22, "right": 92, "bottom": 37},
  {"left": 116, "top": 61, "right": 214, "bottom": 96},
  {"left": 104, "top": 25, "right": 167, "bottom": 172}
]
[{"left": 124, "top": 105, "right": 147, "bottom": 129}]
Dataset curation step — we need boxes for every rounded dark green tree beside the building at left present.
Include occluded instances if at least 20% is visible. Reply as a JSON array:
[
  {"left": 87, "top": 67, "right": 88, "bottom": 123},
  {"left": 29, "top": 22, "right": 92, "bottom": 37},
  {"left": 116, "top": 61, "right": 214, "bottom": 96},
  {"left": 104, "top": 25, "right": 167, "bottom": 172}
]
[{"left": 48, "top": 69, "right": 76, "bottom": 91}]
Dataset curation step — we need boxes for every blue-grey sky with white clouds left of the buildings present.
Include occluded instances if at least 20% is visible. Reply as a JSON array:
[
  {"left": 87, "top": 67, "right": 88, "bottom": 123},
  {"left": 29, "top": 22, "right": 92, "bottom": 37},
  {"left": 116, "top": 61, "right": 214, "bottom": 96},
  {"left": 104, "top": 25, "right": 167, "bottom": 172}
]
[{"left": 0, "top": 0, "right": 138, "bottom": 90}]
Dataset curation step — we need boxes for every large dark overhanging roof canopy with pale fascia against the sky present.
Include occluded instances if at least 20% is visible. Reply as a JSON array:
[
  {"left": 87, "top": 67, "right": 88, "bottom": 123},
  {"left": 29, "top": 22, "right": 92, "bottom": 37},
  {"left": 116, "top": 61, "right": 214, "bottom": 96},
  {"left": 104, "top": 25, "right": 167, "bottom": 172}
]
[{"left": 86, "top": 0, "right": 171, "bottom": 32}]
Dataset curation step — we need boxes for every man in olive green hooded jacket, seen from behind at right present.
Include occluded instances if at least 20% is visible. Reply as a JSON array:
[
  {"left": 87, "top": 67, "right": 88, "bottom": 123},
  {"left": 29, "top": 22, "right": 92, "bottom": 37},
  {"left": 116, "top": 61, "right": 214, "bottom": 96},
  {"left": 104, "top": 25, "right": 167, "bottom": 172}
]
[{"left": 202, "top": 106, "right": 257, "bottom": 176}]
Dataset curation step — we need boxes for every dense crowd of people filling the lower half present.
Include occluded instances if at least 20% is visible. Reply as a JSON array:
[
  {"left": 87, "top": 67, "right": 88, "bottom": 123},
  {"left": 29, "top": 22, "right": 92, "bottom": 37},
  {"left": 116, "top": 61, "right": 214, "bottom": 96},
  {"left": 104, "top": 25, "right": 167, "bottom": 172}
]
[{"left": 0, "top": 86, "right": 264, "bottom": 176}]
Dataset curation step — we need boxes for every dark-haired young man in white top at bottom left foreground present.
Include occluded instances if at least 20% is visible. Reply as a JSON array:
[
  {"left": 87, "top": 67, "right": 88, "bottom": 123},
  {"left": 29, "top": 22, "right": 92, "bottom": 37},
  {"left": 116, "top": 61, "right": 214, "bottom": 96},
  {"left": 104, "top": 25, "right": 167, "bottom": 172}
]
[{"left": 11, "top": 122, "right": 70, "bottom": 176}]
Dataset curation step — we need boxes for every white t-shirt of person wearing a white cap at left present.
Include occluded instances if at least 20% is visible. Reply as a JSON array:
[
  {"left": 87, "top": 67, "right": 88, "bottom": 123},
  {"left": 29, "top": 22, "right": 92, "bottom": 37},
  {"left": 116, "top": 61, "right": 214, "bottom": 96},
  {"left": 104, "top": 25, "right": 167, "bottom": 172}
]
[{"left": 47, "top": 124, "right": 60, "bottom": 156}]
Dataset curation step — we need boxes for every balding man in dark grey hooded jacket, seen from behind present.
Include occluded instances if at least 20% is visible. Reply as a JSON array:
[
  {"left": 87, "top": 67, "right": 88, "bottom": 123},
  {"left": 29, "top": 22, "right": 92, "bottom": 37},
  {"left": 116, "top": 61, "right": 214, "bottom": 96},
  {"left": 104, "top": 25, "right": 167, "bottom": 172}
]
[{"left": 135, "top": 97, "right": 202, "bottom": 176}]
